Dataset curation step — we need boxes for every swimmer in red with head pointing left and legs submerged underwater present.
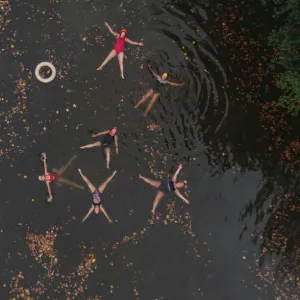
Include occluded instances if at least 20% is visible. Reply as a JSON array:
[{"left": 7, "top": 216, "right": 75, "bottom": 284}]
[{"left": 39, "top": 155, "right": 84, "bottom": 202}]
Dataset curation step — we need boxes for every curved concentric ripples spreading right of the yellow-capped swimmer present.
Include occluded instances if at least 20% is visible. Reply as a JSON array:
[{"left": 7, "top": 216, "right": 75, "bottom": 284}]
[{"left": 131, "top": 2, "right": 229, "bottom": 168}]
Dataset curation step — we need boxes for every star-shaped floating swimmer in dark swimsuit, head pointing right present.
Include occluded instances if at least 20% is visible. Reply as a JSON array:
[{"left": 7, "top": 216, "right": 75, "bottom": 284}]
[{"left": 139, "top": 164, "right": 190, "bottom": 214}]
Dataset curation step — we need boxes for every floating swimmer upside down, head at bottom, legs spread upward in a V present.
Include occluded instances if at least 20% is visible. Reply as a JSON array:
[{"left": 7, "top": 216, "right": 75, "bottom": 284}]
[{"left": 78, "top": 169, "right": 117, "bottom": 223}]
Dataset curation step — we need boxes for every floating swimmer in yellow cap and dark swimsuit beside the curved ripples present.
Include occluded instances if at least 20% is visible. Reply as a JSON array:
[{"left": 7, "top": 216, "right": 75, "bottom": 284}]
[{"left": 134, "top": 65, "right": 184, "bottom": 117}]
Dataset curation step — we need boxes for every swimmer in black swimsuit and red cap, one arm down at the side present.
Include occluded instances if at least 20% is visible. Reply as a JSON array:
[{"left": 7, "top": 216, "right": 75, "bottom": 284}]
[{"left": 80, "top": 127, "right": 119, "bottom": 169}]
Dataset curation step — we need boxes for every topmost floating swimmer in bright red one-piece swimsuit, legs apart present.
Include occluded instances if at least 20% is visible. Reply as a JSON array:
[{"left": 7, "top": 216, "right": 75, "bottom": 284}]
[{"left": 97, "top": 22, "right": 144, "bottom": 79}]
